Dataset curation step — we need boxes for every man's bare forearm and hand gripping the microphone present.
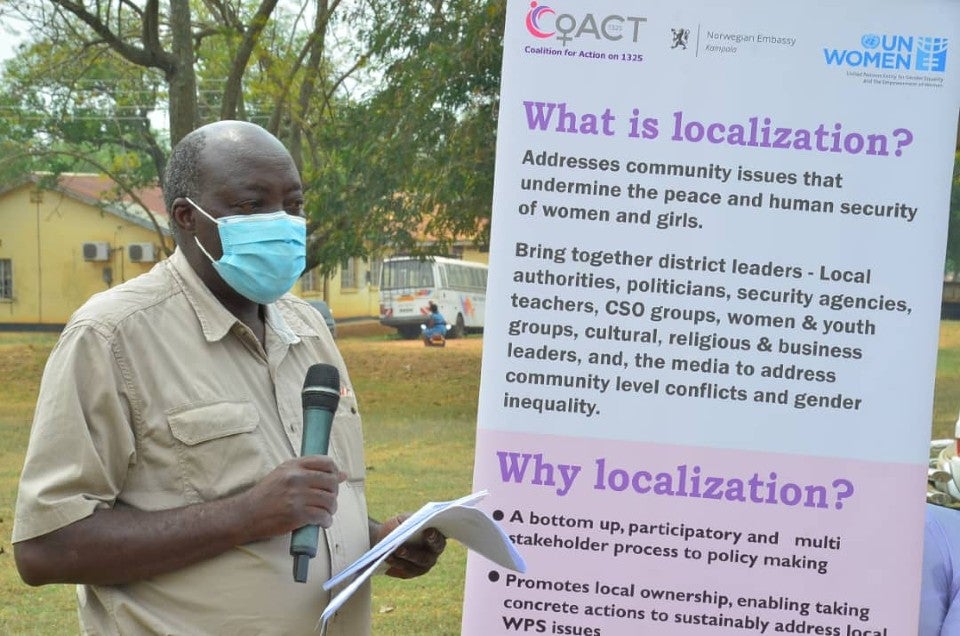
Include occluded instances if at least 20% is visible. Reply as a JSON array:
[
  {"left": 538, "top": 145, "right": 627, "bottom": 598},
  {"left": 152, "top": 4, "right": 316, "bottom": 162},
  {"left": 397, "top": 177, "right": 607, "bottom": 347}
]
[{"left": 14, "top": 455, "right": 346, "bottom": 585}]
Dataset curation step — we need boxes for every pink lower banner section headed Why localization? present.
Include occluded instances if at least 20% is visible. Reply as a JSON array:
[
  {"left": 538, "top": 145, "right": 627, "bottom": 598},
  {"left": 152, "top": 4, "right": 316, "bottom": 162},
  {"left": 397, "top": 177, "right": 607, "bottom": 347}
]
[{"left": 463, "top": 430, "right": 925, "bottom": 636}]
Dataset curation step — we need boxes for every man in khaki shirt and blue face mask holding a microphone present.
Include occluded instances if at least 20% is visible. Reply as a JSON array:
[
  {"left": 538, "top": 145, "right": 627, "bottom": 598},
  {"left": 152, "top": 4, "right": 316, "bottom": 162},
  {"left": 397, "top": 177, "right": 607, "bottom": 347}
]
[{"left": 13, "top": 121, "right": 444, "bottom": 636}]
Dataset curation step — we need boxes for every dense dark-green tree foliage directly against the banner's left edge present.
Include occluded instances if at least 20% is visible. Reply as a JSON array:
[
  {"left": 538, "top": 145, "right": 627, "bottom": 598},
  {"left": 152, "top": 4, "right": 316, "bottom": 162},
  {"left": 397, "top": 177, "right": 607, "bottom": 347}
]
[{"left": 309, "top": 0, "right": 505, "bottom": 264}]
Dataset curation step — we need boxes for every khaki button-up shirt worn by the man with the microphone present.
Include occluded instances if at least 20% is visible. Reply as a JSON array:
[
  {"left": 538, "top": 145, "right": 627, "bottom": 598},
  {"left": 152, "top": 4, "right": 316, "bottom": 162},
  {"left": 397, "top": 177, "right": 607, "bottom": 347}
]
[{"left": 13, "top": 251, "right": 370, "bottom": 636}]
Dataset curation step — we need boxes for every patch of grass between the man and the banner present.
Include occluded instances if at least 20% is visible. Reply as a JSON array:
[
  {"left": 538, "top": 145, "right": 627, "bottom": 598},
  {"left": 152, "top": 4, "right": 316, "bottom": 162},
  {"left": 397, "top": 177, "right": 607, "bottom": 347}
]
[{"left": 340, "top": 337, "right": 481, "bottom": 635}]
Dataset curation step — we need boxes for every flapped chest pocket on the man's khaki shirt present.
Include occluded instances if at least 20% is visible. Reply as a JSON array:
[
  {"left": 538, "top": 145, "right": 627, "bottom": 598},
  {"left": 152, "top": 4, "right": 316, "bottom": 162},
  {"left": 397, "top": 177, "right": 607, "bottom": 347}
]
[{"left": 166, "top": 401, "right": 269, "bottom": 503}]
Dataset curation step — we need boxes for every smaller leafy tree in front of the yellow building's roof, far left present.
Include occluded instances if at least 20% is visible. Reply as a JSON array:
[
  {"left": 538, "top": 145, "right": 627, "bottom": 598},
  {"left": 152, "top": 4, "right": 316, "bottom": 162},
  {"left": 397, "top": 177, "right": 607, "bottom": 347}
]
[{"left": 0, "top": 31, "right": 172, "bottom": 248}]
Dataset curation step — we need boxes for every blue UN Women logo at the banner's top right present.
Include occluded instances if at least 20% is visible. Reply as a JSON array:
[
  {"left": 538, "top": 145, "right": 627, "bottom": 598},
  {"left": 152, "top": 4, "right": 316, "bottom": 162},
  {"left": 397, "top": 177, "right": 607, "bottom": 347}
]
[{"left": 823, "top": 33, "right": 948, "bottom": 73}]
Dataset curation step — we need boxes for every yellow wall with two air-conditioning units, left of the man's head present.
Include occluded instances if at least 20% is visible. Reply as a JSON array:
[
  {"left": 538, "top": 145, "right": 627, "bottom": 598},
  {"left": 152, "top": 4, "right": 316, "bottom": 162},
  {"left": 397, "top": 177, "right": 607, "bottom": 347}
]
[{"left": 0, "top": 183, "right": 167, "bottom": 325}]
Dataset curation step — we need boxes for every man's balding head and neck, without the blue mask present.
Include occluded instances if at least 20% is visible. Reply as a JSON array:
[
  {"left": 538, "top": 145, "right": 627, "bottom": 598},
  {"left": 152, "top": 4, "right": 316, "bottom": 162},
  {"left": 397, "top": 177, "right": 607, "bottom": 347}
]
[{"left": 163, "top": 121, "right": 303, "bottom": 306}]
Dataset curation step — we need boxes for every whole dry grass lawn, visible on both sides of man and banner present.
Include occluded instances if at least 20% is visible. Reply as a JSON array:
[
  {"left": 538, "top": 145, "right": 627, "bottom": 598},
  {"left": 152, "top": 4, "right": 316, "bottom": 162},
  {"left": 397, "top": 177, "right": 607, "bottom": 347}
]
[{"left": 0, "top": 322, "right": 960, "bottom": 636}]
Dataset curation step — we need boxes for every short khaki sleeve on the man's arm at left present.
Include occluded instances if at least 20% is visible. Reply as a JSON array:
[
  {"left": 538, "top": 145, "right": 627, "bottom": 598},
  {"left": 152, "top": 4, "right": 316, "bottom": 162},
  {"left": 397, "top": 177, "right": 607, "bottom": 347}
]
[{"left": 13, "top": 323, "right": 136, "bottom": 542}]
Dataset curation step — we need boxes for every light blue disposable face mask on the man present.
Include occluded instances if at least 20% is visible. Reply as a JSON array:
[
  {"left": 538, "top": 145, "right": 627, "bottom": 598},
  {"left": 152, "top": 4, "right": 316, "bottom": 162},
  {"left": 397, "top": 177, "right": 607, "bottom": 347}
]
[{"left": 186, "top": 197, "right": 307, "bottom": 305}]
